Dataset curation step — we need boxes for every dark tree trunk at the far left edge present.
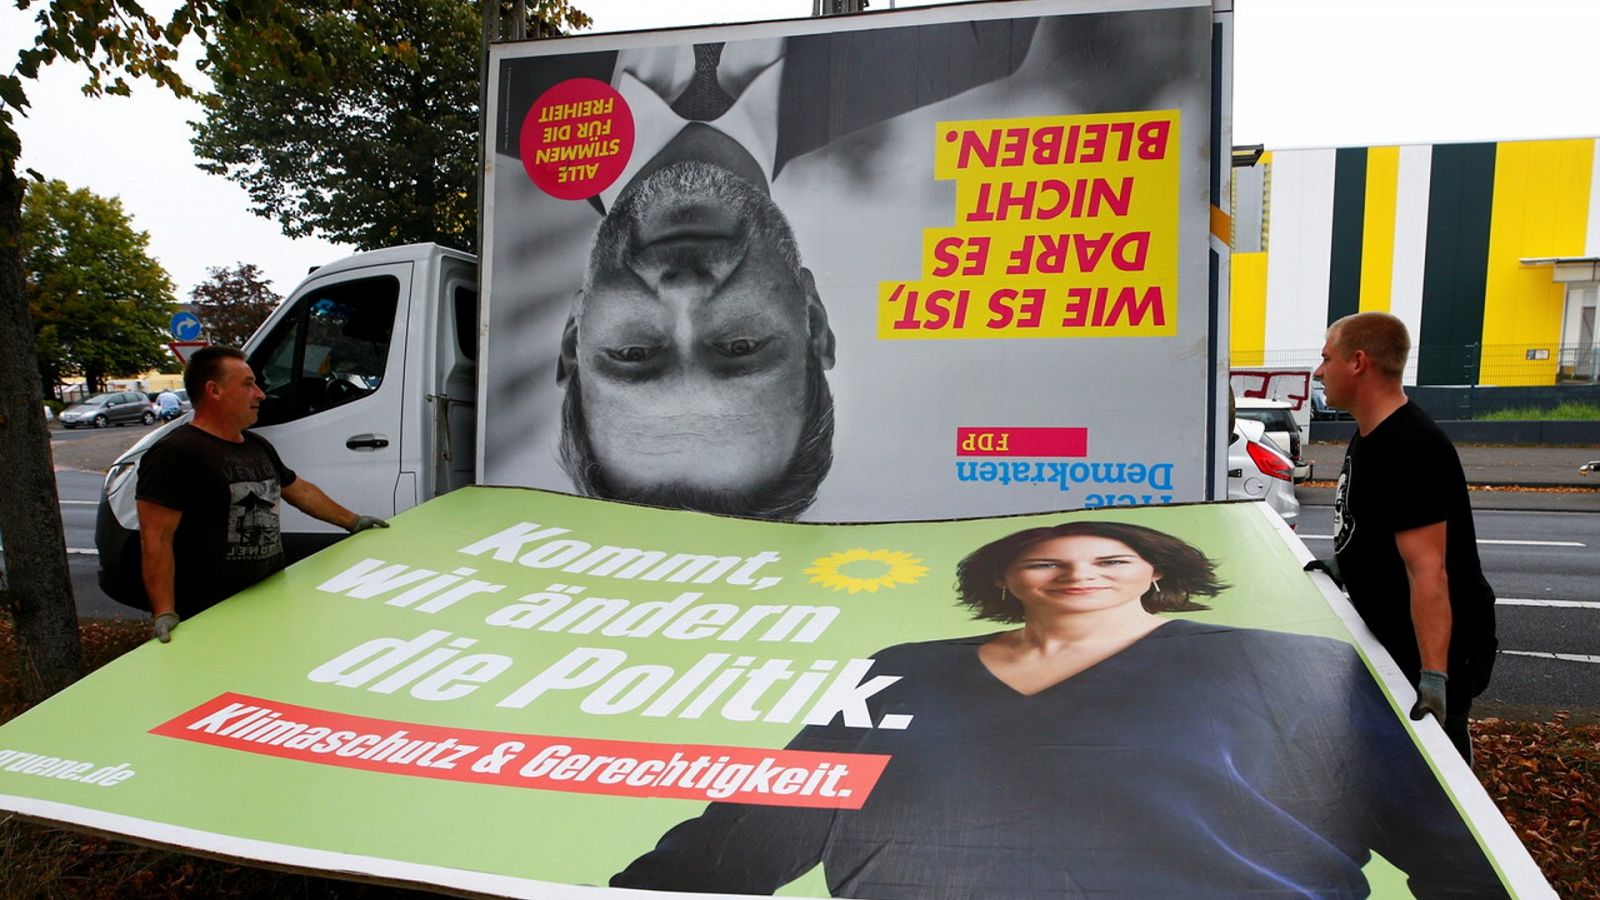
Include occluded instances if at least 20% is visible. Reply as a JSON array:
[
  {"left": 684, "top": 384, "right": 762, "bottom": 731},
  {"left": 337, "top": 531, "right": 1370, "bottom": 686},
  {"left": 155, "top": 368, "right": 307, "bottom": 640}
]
[{"left": 0, "top": 160, "right": 83, "bottom": 701}]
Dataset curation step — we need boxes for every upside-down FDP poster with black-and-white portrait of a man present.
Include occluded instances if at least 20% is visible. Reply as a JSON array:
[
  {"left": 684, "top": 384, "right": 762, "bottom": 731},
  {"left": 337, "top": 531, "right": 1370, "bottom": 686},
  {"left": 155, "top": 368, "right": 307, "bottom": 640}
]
[{"left": 478, "top": 0, "right": 1227, "bottom": 522}]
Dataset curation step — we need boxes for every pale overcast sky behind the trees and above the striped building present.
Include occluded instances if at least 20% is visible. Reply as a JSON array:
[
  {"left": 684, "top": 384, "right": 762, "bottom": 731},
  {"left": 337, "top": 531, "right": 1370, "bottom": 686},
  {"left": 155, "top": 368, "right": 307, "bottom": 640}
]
[{"left": 12, "top": 0, "right": 1600, "bottom": 299}]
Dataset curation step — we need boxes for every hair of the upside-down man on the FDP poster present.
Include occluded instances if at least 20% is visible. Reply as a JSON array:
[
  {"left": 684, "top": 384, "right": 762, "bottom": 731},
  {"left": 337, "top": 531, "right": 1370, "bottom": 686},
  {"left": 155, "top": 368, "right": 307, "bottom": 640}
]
[{"left": 562, "top": 352, "right": 834, "bottom": 522}]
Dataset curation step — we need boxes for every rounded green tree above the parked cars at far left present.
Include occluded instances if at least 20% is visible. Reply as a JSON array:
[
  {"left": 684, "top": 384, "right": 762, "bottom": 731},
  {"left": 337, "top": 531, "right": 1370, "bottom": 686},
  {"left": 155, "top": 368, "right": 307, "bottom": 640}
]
[{"left": 22, "top": 181, "right": 174, "bottom": 391}]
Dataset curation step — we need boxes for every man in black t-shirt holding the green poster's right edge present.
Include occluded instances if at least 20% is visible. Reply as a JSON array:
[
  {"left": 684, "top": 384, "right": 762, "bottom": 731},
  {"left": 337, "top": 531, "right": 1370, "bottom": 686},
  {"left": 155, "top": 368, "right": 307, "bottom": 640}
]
[{"left": 1315, "top": 312, "right": 1498, "bottom": 762}]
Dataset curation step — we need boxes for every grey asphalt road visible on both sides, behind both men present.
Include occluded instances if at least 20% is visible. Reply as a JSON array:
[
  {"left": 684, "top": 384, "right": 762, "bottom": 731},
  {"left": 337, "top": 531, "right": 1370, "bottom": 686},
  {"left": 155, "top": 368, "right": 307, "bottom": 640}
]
[{"left": 51, "top": 426, "right": 1600, "bottom": 721}]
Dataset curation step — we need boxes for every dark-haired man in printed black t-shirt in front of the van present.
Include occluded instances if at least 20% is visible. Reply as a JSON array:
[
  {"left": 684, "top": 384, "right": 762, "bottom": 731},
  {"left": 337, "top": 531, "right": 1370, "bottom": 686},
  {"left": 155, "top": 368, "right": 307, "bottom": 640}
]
[{"left": 138, "top": 348, "right": 389, "bottom": 644}]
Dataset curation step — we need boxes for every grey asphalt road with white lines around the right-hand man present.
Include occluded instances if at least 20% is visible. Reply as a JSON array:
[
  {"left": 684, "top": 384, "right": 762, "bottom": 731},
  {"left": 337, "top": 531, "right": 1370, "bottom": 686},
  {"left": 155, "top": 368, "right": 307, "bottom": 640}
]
[{"left": 1299, "top": 506, "right": 1600, "bottom": 721}]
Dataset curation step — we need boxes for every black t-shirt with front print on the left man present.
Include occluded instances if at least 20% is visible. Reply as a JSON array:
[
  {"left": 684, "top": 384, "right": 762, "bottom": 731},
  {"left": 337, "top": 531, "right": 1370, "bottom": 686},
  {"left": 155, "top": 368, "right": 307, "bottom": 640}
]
[{"left": 138, "top": 424, "right": 296, "bottom": 618}]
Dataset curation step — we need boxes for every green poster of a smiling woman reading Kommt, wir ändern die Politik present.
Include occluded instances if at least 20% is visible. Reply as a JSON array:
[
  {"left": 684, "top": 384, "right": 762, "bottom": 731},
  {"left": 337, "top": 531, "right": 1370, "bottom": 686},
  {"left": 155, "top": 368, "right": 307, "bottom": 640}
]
[{"left": 0, "top": 488, "right": 1547, "bottom": 900}]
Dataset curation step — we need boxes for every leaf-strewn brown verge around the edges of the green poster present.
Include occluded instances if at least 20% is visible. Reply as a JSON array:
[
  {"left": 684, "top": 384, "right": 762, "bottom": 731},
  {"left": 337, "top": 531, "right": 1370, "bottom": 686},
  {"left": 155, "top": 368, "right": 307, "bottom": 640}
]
[{"left": 0, "top": 617, "right": 1600, "bottom": 900}]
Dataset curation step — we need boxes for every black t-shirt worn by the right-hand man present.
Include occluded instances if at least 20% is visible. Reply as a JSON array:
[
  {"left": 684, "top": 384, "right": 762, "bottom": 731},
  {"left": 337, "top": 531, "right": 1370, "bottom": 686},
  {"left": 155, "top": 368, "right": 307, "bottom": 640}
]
[{"left": 1334, "top": 402, "right": 1496, "bottom": 697}]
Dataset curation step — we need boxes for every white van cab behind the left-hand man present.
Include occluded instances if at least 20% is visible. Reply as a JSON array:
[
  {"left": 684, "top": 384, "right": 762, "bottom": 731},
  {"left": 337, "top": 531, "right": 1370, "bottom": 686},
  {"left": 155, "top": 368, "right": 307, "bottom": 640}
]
[{"left": 94, "top": 243, "right": 478, "bottom": 607}]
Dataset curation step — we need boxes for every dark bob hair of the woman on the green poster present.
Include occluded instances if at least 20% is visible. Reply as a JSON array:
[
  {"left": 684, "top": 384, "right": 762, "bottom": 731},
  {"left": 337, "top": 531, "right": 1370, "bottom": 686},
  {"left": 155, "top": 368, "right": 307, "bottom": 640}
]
[{"left": 955, "top": 522, "right": 1227, "bottom": 621}]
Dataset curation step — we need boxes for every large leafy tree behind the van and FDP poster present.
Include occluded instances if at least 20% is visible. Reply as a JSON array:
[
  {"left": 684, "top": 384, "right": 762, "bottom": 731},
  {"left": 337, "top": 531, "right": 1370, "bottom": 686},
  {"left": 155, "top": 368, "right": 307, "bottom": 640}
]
[{"left": 194, "top": 0, "right": 589, "bottom": 250}]
